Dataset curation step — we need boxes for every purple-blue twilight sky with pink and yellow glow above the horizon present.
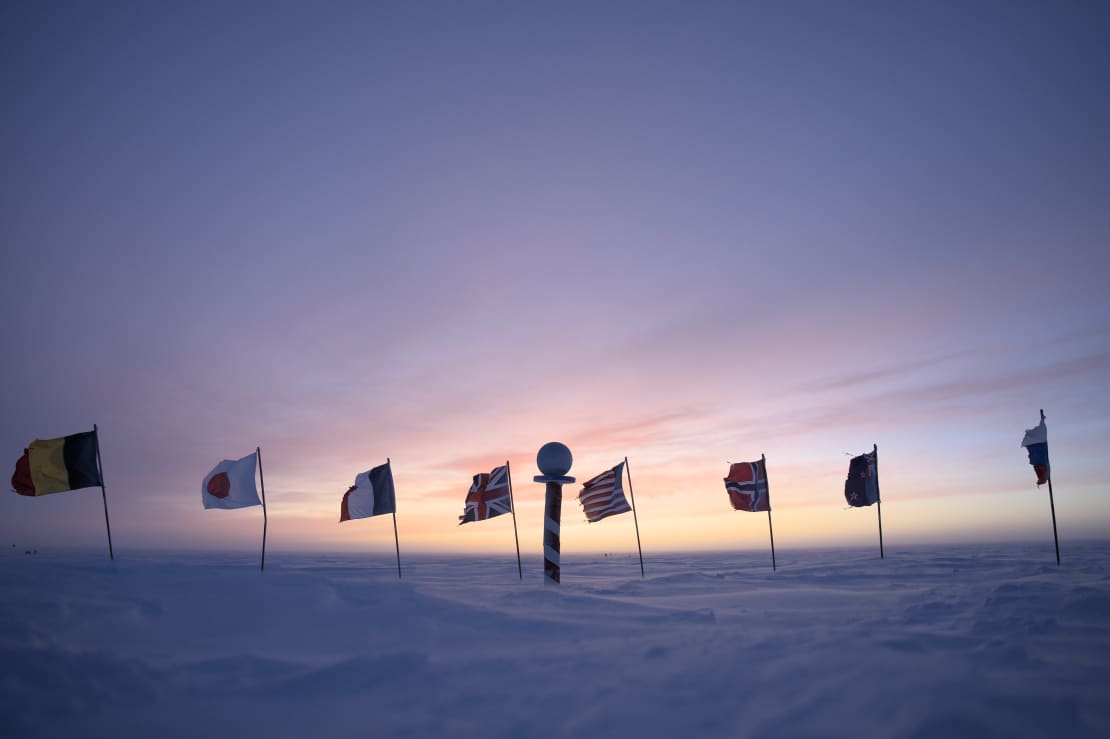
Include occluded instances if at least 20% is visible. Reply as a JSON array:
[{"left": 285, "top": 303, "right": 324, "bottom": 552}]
[{"left": 0, "top": 0, "right": 1110, "bottom": 557}]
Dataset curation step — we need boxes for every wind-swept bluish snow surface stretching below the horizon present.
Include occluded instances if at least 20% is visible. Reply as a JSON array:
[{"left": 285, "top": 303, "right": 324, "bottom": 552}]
[{"left": 0, "top": 543, "right": 1110, "bottom": 737}]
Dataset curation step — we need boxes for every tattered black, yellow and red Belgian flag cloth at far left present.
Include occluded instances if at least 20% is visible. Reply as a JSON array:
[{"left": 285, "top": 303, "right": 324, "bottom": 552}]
[{"left": 11, "top": 431, "right": 103, "bottom": 495}]
